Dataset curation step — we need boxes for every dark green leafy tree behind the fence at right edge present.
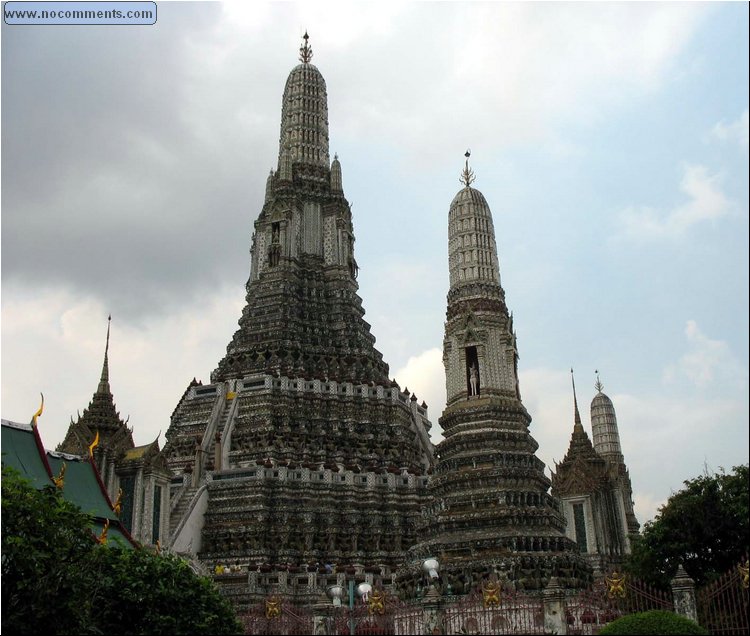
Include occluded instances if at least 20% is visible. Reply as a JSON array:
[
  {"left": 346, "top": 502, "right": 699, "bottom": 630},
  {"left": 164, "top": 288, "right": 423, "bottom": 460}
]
[{"left": 625, "top": 465, "right": 750, "bottom": 589}]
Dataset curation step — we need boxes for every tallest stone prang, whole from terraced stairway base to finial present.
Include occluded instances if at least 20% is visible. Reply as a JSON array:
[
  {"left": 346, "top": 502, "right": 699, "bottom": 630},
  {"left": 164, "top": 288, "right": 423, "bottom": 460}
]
[{"left": 165, "top": 34, "right": 433, "bottom": 607}]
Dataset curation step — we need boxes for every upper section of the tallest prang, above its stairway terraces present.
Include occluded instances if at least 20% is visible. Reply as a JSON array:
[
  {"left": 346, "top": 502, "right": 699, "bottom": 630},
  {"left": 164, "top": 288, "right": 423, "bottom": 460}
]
[{"left": 211, "top": 32, "right": 388, "bottom": 385}]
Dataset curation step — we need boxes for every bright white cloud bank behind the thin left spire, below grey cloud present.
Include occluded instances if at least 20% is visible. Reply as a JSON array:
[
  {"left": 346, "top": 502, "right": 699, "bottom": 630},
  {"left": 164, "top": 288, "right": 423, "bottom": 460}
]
[{"left": 2, "top": 280, "right": 244, "bottom": 448}]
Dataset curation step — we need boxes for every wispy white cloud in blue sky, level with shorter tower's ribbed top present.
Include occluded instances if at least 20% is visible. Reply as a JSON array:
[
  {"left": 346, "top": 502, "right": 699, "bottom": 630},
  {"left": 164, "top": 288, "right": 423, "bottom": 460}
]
[{"left": 620, "top": 165, "right": 731, "bottom": 240}]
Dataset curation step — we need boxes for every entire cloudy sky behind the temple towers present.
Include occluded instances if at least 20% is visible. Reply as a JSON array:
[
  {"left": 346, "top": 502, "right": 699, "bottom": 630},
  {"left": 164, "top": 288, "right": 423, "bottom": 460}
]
[{"left": 2, "top": 2, "right": 748, "bottom": 522}]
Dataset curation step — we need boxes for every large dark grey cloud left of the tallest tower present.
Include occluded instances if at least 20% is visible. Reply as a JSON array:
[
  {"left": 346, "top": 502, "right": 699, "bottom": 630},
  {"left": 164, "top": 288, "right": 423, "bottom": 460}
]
[{"left": 2, "top": 4, "right": 290, "bottom": 320}]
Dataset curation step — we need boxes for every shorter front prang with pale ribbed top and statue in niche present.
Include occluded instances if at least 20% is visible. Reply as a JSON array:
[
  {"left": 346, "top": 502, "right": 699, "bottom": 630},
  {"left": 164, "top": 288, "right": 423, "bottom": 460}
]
[{"left": 401, "top": 157, "right": 590, "bottom": 593}]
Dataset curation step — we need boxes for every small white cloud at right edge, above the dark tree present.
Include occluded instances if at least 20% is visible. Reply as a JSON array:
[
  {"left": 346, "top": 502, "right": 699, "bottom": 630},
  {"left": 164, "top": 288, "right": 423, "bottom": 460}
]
[{"left": 663, "top": 320, "right": 748, "bottom": 389}]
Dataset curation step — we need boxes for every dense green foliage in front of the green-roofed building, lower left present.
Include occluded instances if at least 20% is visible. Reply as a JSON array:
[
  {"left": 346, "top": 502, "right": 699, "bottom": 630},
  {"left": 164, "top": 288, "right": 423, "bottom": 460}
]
[{"left": 2, "top": 468, "right": 242, "bottom": 634}]
